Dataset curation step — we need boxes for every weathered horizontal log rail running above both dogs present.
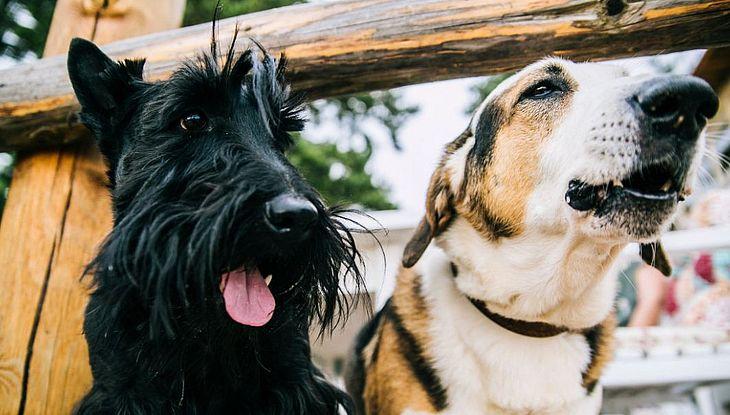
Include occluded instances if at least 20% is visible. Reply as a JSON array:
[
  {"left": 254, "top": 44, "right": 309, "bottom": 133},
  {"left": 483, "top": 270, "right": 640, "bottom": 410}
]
[{"left": 0, "top": 0, "right": 730, "bottom": 149}]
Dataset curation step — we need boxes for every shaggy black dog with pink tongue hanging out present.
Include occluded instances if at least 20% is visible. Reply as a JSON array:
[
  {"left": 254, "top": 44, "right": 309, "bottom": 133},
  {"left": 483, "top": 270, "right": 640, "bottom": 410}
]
[{"left": 68, "top": 27, "right": 362, "bottom": 414}]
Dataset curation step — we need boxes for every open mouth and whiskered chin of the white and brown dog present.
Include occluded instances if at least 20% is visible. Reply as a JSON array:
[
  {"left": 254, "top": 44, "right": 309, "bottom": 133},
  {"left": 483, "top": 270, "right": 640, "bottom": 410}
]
[{"left": 565, "top": 163, "right": 686, "bottom": 242}]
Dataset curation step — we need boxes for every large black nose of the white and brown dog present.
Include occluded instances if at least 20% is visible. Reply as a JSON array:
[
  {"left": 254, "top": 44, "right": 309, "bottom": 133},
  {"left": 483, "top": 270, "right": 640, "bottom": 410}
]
[{"left": 634, "top": 75, "right": 719, "bottom": 140}]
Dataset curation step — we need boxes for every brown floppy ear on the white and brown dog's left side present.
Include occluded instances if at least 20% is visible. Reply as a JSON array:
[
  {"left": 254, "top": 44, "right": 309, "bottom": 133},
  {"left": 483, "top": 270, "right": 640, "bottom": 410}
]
[{"left": 403, "top": 163, "right": 454, "bottom": 268}]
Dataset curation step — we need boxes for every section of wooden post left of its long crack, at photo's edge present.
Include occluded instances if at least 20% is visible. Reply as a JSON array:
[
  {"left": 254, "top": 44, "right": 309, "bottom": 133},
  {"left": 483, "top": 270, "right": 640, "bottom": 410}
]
[{"left": 0, "top": 151, "right": 75, "bottom": 414}]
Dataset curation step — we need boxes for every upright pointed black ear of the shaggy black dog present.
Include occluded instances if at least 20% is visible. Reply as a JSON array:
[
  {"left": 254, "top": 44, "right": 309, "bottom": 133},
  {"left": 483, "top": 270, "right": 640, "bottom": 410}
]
[{"left": 67, "top": 38, "right": 144, "bottom": 132}]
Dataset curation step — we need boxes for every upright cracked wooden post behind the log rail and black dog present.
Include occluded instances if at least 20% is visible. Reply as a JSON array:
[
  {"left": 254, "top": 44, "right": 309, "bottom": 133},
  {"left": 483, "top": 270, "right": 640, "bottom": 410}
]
[{"left": 0, "top": 0, "right": 185, "bottom": 414}]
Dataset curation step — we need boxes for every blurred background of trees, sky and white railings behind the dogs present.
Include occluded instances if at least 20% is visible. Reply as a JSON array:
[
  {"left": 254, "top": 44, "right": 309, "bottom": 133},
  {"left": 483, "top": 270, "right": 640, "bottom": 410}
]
[{"left": 0, "top": 0, "right": 730, "bottom": 415}]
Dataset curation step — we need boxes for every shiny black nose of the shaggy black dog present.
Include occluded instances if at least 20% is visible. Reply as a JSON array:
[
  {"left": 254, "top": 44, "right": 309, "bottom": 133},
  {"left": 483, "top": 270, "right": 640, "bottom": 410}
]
[{"left": 265, "top": 193, "right": 318, "bottom": 237}]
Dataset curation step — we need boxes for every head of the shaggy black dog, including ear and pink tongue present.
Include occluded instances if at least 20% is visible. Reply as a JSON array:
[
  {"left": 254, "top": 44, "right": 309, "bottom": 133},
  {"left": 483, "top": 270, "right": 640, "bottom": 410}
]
[{"left": 68, "top": 39, "right": 360, "bottom": 333}]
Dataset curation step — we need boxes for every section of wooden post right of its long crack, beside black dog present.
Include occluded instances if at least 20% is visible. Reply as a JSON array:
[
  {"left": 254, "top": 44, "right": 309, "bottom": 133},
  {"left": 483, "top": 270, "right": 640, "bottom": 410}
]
[{"left": 21, "top": 143, "right": 106, "bottom": 414}]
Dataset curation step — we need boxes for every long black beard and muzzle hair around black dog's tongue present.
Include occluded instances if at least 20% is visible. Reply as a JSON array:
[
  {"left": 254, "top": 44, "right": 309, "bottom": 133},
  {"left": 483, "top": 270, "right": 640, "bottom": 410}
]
[{"left": 89, "top": 145, "right": 363, "bottom": 338}]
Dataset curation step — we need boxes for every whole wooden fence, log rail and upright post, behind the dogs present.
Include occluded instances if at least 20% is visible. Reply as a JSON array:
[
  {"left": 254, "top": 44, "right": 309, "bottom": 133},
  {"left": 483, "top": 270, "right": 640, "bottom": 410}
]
[{"left": 0, "top": 0, "right": 730, "bottom": 414}]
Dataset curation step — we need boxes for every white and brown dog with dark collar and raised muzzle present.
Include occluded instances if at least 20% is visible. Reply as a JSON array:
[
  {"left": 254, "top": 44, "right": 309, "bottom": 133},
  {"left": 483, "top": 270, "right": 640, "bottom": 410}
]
[{"left": 347, "top": 59, "right": 718, "bottom": 415}]
